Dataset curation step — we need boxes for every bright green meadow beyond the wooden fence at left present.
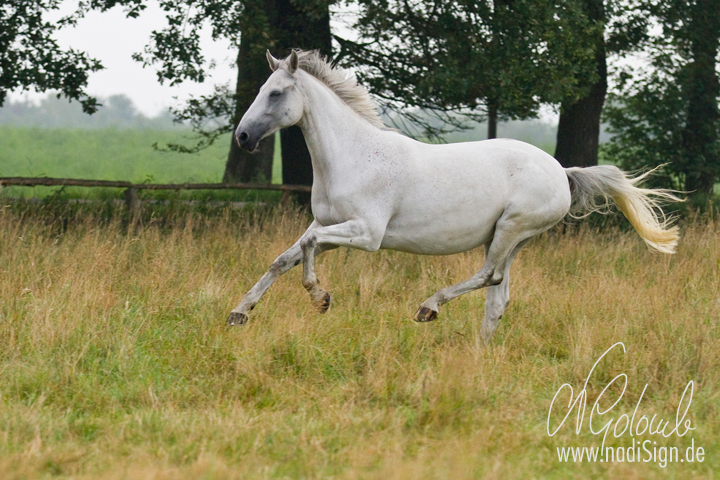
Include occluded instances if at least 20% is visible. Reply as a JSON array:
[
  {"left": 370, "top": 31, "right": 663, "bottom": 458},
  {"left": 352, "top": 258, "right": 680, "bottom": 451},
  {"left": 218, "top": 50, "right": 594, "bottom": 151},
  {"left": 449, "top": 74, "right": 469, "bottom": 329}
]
[{"left": 0, "top": 126, "right": 282, "bottom": 199}]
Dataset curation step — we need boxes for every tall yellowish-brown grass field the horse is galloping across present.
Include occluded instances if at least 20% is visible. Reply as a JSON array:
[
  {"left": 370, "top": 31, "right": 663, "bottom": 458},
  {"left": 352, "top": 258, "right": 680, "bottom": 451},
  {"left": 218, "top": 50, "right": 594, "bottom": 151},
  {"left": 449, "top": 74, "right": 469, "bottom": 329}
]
[{"left": 0, "top": 203, "right": 720, "bottom": 480}]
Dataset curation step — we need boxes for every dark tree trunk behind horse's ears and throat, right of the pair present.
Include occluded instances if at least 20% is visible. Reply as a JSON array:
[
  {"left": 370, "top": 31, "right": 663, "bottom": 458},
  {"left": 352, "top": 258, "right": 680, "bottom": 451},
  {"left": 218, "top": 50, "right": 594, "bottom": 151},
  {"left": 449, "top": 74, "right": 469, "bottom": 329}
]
[{"left": 271, "top": 0, "right": 332, "bottom": 205}]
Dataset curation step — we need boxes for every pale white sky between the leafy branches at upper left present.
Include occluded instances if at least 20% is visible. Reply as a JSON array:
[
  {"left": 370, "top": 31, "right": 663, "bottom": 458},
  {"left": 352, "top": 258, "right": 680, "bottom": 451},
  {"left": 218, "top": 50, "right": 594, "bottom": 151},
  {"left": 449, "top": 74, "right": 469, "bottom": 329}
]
[{"left": 9, "top": 1, "right": 236, "bottom": 116}]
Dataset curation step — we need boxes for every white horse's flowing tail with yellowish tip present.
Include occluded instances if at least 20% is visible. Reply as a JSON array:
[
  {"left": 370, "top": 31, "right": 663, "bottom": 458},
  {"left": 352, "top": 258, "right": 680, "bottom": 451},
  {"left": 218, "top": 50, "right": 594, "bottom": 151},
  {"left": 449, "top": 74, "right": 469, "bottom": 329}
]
[{"left": 565, "top": 165, "right": 682, "bottom": 253}]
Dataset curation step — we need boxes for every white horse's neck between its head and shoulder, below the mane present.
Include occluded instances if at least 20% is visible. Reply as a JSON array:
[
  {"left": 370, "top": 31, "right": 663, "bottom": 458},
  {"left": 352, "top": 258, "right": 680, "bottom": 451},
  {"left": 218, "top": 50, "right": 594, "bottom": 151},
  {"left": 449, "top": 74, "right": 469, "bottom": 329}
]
[{"left": 299, "top": 72, "right": 378, "bottom": 178}]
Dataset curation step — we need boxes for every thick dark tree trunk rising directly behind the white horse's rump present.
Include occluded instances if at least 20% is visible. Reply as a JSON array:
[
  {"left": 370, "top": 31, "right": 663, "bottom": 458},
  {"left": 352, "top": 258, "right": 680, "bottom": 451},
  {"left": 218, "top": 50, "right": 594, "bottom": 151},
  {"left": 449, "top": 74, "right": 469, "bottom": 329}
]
[{"left": 555, "top": 0, "right": 607, "bottom": 168}]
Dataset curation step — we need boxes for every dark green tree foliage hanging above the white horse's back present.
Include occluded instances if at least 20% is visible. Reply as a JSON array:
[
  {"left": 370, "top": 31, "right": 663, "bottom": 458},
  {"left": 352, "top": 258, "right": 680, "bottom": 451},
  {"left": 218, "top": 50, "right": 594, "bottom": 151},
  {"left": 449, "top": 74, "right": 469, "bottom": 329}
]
[{"left": 336, "top": 0, "right": 596, "bottom": 136}]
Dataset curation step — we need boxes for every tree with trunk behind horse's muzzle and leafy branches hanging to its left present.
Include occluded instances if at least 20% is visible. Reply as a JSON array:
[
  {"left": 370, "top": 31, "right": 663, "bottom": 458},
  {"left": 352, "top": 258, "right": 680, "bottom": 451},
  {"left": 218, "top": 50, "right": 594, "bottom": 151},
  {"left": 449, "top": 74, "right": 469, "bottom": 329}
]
[{"left": 115, "top": 0, "right": 274, "bottom": 182}]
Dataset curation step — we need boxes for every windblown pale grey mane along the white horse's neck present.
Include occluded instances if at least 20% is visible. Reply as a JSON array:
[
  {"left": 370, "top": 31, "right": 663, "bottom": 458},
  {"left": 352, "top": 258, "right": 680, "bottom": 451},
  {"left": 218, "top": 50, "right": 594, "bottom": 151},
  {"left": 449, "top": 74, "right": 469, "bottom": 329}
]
[{"left": 282, "top": 50, "right": 387, "bottom": 129}]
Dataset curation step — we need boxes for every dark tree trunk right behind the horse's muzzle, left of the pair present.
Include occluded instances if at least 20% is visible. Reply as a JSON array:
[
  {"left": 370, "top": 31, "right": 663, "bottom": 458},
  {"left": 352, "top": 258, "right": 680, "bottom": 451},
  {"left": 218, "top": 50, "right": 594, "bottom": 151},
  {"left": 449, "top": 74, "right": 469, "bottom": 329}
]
[{"left": 223, "top": 2, "right": 275, "bottom": 183}]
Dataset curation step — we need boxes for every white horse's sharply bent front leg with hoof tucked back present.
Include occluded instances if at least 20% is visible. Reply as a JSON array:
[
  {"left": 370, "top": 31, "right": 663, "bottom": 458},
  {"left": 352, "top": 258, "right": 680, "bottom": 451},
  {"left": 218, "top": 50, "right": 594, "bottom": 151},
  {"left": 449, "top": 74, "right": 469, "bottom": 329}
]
[{"left": 300, "top": 219, "right": 382, "bottom": 313}]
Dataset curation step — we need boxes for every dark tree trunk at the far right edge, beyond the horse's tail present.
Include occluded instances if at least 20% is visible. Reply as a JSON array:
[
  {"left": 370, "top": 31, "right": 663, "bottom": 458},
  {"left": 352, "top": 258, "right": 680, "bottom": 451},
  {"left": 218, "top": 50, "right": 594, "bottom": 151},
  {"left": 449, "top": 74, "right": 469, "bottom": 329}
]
[{"left": 682, "top": 0, "right": 720, "bottom": 200}]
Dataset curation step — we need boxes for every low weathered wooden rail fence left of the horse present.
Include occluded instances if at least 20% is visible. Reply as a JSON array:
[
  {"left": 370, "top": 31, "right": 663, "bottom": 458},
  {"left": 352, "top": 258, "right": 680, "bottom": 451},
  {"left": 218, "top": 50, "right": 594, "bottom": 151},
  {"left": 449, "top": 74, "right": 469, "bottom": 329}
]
[{"left": 0, "top": 177, "right": 312, "bottom": 210}]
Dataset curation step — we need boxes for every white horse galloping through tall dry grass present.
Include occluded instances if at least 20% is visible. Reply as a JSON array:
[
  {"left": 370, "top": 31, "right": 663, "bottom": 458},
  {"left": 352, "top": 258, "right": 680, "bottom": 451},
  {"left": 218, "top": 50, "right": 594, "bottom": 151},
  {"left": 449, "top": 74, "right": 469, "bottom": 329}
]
[{"left": 227, "top": 51, "right": 678, "bottom": 341}]
